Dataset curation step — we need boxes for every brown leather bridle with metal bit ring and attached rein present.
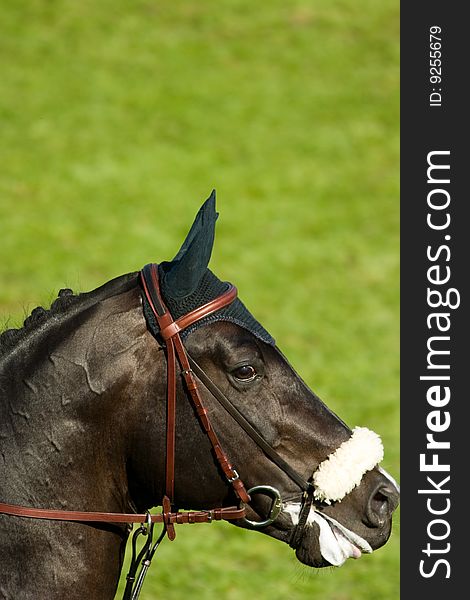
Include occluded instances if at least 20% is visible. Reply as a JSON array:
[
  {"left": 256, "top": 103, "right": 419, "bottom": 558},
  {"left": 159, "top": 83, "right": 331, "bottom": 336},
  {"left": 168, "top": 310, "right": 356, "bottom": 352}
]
[{"left": 0, "top": 263, "right": 313, "bottom": 599}]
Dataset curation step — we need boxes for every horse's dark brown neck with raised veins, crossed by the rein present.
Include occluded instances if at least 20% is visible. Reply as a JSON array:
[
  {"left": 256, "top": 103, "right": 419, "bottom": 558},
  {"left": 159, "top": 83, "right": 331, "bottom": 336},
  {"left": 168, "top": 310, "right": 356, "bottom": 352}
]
[{"left": 0, "top": 286, "right": 162, "bottom": 598}]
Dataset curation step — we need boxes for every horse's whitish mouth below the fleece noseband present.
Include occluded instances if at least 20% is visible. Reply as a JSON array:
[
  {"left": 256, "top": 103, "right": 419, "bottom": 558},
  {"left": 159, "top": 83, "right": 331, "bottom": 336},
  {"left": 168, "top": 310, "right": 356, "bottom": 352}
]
[{"left": 284, "top": 505, "right": 372, "bottom": 568}]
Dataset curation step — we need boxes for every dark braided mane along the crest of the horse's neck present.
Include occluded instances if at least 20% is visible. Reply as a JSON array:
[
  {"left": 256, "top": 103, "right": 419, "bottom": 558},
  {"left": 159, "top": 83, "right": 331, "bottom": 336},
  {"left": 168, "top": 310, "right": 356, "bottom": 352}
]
[{"left": 0, "top": 273, "right": 136, "bottom": 356}]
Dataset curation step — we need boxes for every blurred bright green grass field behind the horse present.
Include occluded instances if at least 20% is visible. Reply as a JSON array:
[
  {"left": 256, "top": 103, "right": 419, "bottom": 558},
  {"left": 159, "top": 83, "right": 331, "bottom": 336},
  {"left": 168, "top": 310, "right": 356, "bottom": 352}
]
[{"left": 0, "top": 0, "right": 399, "bottom": 600}]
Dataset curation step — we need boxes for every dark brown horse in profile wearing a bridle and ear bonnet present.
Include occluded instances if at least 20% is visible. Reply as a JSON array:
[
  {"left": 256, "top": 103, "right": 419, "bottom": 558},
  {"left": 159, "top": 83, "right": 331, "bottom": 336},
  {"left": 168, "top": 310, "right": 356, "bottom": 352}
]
[{"left": 0, "top": 196, "right": 398, "bottom": 600}]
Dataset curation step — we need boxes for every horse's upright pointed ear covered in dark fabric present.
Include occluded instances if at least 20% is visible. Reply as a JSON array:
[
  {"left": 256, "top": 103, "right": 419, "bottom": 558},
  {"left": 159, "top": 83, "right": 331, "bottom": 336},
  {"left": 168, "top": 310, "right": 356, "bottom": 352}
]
[{"left": 161, "top": 190, "right": 219, "bottom": 298}]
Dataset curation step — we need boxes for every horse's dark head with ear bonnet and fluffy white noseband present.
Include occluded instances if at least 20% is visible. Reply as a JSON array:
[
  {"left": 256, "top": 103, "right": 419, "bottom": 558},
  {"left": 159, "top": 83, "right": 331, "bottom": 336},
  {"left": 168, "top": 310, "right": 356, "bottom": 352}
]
[{"left": 126, "top": 194, "right": 398, "bottom": 567}]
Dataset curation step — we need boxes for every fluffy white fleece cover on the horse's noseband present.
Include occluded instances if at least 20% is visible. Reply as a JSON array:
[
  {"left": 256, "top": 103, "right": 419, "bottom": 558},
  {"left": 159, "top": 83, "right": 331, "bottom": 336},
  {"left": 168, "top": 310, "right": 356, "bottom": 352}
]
[{"left": 313, "top": 427, "right": 384, "bottom": 504}]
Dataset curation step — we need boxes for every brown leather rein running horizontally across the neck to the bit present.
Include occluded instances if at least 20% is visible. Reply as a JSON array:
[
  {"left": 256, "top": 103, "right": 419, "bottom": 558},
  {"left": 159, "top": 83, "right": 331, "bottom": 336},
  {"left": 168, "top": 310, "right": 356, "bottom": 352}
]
[{"left": 0, "top": 502, "right": 246, "bottom": 525}]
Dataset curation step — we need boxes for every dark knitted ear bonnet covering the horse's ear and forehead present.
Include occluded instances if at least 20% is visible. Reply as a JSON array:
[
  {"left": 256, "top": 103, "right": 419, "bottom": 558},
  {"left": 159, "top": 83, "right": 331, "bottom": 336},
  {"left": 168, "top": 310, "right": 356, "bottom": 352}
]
[{"left": 144, "top": 190, "right": 275, "bottom": 345}]
